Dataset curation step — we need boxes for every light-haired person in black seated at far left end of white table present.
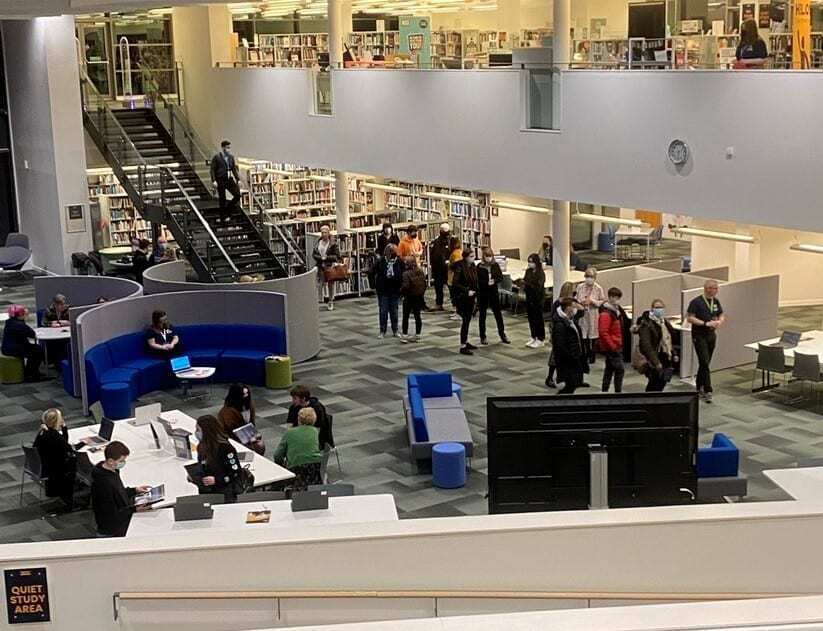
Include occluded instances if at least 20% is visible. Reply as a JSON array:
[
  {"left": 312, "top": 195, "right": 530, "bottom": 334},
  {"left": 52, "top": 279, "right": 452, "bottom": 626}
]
[{"left": 34, "top": 408, "right": 77, "bottom": 512}]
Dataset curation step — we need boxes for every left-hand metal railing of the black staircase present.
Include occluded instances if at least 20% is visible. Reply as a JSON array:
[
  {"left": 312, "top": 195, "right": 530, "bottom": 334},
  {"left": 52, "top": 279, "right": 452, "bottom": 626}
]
[{"left": 80, "top": 66, "right": 237, "bottom": 281}]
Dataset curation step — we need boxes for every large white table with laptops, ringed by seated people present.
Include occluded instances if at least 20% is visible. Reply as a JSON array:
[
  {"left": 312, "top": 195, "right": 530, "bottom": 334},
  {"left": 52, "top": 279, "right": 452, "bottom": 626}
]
[{"left": 69, "top": 410, "right": 294, "bottom": 507}]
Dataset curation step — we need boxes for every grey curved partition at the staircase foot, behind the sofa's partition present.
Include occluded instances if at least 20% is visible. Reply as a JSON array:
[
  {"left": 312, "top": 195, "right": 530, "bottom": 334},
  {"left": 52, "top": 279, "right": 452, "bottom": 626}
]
[{"left": 143, "top": 261, "right": 320, "bottom": 363}]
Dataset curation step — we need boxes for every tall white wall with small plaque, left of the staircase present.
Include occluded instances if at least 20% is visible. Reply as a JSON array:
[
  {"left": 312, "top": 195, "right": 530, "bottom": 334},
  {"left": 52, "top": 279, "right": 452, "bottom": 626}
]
[{"left": 3, "top": 16, "right": 92, "bottom": 274}]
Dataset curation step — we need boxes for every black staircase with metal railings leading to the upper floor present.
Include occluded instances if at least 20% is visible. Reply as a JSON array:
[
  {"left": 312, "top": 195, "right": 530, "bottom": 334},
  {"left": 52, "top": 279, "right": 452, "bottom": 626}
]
[{"left": 81, "top": 72, "right": 288, "bottom": 283}]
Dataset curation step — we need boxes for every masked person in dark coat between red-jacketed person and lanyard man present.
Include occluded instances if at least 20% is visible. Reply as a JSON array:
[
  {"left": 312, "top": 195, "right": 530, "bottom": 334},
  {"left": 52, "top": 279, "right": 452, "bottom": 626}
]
[{"left": 632, "top": 298, "right": 678, "bottom": 392}]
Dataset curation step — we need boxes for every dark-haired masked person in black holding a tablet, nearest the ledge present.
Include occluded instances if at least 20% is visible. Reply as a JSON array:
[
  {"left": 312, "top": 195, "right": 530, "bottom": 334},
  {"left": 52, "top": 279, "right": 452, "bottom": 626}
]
[{"left": 91, "top": 440, "right": 151, "bottom": 537}]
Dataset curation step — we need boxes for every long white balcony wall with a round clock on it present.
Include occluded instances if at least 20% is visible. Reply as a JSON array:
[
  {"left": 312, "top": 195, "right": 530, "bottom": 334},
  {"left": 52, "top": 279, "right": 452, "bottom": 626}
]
[{"left": 196, "top": 69, "right": 823, "bottom": 237}]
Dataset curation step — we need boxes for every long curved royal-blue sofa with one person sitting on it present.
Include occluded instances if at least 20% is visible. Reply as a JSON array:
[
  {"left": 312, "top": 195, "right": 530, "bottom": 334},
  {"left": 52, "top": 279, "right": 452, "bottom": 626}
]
[{"left": 85, "top": 324, "right": 287, "bottom": 403}]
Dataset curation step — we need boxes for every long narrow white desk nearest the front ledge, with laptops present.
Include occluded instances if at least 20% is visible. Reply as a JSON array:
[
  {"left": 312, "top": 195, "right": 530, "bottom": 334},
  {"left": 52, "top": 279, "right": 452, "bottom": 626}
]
[{"left": 126, "top": 495, "right": 398, "bottom": 537}]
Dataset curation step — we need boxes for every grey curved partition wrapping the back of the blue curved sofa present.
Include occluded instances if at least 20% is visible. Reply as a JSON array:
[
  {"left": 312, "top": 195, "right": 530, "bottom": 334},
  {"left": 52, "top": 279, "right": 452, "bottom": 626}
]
[{"left": 76, "top": 290, "right": 290, "bottom": 413}]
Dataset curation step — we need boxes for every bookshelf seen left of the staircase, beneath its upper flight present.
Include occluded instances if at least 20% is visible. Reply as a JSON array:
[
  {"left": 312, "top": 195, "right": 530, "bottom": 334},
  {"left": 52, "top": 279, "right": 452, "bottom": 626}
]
[{"left": 86, "top": 168, "right": 174, "bottom": 250}]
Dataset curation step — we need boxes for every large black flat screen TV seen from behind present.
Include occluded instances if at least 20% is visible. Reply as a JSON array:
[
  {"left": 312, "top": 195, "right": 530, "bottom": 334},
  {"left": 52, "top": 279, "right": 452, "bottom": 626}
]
[{"left": 486, "top": 392, "right": 698, "bottom": 514}]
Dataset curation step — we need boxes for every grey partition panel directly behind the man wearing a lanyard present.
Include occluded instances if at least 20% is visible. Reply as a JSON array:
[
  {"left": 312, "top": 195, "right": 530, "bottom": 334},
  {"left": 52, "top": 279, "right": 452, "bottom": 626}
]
[{"left": 681, "top": 274, "right": 780, "bottom": 376}]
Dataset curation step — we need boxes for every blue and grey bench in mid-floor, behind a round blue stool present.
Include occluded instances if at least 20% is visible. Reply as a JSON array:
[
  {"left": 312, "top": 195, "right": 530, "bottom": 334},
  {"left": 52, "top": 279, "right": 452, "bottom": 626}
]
[{"left": 403, "top": 373, "right": 474, "bottom": 460}]
